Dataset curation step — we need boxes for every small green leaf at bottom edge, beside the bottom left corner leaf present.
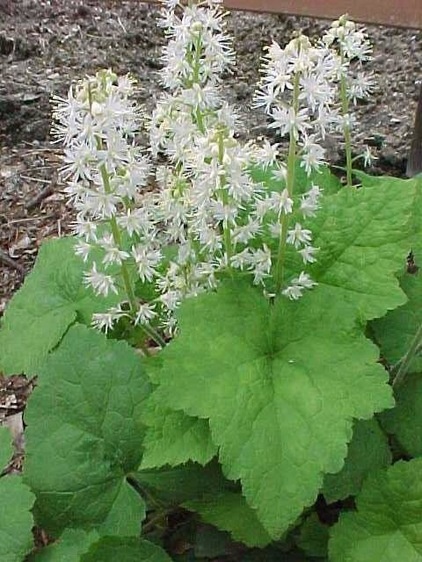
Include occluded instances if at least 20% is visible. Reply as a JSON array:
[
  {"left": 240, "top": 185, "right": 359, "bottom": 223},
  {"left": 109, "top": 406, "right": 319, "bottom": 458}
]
[{"left": 28, "top": 529, "right": 98, "bottom": 562}]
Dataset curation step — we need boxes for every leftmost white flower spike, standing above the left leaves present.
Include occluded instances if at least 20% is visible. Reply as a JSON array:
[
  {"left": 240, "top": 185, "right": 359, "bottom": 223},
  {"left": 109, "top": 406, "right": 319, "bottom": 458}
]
[{"left": 53, "top": 70, "right": 151, "bottom": 329}]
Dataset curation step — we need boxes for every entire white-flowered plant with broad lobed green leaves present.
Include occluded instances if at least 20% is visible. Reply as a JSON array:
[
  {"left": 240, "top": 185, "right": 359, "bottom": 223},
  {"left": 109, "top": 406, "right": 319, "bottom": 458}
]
[{"left": 0, "top": 0, "right": 422, "bottom": 562}]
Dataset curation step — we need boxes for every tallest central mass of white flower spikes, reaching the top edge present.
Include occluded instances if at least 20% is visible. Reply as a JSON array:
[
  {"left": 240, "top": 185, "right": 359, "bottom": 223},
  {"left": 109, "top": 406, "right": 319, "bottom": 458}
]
[{"left": 145, "top": 3, "right": 282, "bottom": 328}]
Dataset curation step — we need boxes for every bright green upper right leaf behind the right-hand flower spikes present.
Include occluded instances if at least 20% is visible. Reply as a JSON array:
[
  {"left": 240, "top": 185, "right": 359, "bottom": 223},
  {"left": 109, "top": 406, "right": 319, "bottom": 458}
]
[{"left": 309, "top": 178, "right": 415, "bottom": 322}]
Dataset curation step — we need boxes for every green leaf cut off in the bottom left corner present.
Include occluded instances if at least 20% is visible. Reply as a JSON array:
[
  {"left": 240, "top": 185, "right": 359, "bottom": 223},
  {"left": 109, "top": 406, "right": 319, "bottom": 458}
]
[{"left": 0, "top": 475, "right": 35, "bottom": 562}]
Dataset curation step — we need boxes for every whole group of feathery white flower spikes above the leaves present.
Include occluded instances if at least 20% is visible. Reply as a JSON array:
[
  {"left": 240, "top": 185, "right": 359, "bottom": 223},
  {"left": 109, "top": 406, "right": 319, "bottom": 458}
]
[{"left": 54, "top": 0, "right": 376, "bottom": 344}]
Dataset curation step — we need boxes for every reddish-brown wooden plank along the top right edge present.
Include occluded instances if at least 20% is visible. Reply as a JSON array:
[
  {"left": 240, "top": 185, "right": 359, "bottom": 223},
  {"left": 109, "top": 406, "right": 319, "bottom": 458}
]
[{"left": 224, "top": 0, "right": 422, "bottom": 29}]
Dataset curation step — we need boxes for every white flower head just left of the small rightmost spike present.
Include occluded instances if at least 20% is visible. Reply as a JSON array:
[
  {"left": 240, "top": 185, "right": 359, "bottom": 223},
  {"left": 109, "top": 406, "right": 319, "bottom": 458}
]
[{"left": 255, "top": 35, "right": 339, "bottom": 174}]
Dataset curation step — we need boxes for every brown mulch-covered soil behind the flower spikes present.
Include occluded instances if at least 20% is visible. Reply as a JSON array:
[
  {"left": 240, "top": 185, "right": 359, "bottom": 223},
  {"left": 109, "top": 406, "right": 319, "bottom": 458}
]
[{"left": 0, "top": 0, "right": 422, "bottom": 314}]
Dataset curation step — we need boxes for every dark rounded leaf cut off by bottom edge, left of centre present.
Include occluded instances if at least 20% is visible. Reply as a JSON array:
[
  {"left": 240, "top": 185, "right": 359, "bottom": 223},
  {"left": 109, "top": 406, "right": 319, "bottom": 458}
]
[{"left": 80, "top": 537, "right": 171, "bottom": 562}]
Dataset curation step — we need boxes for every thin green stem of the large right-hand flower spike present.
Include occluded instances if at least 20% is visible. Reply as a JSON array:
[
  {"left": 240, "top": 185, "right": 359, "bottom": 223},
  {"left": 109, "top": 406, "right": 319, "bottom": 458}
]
[{"left": 275, "top": 73, "right": 300, "bottom": 294}]
